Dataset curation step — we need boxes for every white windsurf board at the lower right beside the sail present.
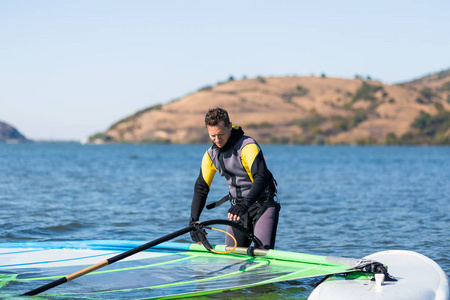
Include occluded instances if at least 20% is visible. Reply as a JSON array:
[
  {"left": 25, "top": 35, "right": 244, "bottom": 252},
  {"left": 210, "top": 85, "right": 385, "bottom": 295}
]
[{"left": 308, "top": 250, "right": 449, "bottom": 300}]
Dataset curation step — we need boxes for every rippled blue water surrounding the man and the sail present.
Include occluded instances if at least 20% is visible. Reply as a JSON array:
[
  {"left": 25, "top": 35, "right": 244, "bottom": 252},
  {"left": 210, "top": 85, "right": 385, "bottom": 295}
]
[{"left": 0, "top": 143, "right": 450, "bottom": 299}]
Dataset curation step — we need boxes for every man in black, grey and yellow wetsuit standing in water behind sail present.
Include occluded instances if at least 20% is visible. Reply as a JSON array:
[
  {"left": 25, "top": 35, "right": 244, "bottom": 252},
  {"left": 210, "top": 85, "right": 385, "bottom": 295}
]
[{"left": 189, "top": 107, "right": 280, "bottom": 249}]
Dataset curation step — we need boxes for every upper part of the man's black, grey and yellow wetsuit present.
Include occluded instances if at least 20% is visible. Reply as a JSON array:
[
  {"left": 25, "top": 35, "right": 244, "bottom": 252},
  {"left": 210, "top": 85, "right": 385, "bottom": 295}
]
[{"left": 191, "top": 127, "right": 279, "bottom": 248}]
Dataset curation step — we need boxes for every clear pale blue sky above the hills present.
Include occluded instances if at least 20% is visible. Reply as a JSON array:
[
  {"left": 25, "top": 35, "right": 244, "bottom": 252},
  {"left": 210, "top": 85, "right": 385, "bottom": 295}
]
[{"left": 0, "top": 0, "right": 450, "bottom": 141}]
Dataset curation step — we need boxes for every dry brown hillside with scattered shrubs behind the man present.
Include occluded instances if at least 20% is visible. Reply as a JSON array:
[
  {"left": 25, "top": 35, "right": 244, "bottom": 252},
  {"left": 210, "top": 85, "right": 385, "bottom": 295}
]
[{"left": 91, "top": 70, "right": 450, "bottom": 144}]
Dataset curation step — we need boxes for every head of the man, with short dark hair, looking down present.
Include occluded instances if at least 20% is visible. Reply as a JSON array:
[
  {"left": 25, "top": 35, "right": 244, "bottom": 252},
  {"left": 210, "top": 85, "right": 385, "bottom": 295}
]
[{"left": 205, "top": 107, "right": 232, "bottom": 148}]
